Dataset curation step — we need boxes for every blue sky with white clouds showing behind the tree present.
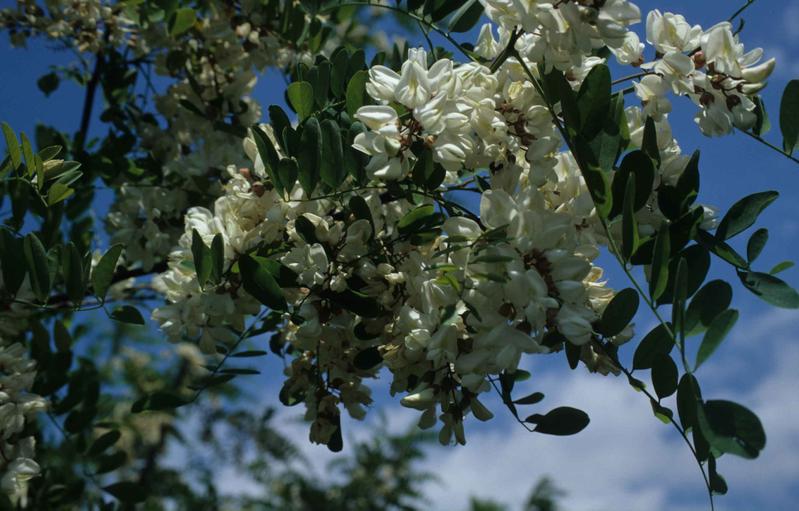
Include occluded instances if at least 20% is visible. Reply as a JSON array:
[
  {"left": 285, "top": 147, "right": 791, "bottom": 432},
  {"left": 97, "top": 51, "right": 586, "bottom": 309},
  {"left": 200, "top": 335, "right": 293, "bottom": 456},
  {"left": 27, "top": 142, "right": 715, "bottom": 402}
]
[{"left": 0, "top": 0, "right": 799, "bottom": 511}]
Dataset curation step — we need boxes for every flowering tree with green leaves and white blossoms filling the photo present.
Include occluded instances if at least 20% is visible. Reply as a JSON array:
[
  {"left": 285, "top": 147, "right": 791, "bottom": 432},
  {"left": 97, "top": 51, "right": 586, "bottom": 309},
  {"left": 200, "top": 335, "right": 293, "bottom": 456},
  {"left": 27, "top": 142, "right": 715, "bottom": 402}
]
[{"left": 0, "top": 0, "right": 799, "bottom": 511}]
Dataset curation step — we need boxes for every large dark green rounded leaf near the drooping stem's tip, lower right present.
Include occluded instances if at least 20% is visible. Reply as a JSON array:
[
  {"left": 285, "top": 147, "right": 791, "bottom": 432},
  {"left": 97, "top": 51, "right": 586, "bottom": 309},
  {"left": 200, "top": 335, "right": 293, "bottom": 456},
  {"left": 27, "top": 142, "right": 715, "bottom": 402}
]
[{"left": 697, "top": 400, "right": 766, "bottom": 459}]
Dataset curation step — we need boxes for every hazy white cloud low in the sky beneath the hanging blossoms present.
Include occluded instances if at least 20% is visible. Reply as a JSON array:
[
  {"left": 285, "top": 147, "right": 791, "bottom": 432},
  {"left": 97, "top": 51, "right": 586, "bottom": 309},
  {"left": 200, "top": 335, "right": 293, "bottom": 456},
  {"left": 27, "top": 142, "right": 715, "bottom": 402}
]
[{"left": 181, "top": 311, "right": 799, "bottom": 511}]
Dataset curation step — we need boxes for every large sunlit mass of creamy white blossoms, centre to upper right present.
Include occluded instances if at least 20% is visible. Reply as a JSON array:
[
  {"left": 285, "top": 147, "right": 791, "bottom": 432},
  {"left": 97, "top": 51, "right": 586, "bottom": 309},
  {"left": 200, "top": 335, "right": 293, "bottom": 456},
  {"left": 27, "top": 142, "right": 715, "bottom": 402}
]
[{"left": 153, "top": 0, "right": 773, "bottom": 443}]
